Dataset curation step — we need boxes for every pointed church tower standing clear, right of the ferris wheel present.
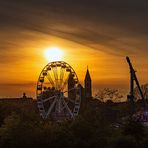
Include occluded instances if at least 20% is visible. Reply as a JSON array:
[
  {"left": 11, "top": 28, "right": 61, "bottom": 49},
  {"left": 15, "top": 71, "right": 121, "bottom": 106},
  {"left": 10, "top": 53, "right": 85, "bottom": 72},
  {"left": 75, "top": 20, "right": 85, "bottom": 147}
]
[{"left": 84, "top": 68, "right": 92, "bottom": 98}]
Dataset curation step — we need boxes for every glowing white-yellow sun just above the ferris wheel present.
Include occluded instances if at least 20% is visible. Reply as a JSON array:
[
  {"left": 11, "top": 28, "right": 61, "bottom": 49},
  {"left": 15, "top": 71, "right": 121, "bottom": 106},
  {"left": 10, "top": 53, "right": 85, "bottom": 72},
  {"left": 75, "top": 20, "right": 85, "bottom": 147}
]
[{"left": 44, "top": 47, "right": 64, "bottom": 62}]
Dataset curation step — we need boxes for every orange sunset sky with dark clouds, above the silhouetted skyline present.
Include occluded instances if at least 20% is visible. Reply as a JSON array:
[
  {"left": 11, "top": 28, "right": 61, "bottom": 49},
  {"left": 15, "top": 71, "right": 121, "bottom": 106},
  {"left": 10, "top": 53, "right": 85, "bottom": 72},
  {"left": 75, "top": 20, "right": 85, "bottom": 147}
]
[{"left": 0, "top": 0, "right": 148, "bottom": 98}]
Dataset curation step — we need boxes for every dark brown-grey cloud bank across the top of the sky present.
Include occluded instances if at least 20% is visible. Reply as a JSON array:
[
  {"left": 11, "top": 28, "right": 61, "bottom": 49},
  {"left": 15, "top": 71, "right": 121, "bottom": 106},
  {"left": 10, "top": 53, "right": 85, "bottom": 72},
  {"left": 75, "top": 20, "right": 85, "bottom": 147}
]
[{"left": 0, "top": 0, "right": 148, "bottom": 59}]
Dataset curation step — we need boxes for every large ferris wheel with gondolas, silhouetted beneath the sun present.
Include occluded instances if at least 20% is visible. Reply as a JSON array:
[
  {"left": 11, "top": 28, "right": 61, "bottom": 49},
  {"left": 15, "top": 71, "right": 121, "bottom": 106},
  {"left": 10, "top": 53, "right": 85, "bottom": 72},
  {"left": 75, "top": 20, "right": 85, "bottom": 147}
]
[{"left": 36, "top": 61, "right": 81, "bottom": 121}]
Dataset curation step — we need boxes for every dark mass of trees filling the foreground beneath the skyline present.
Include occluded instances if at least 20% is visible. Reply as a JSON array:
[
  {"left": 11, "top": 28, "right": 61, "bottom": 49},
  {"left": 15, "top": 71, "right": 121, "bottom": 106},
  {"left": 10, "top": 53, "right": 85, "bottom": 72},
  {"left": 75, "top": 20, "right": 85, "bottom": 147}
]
[{"left": 0, "top": 100, "right": 148, "bottom": 148}]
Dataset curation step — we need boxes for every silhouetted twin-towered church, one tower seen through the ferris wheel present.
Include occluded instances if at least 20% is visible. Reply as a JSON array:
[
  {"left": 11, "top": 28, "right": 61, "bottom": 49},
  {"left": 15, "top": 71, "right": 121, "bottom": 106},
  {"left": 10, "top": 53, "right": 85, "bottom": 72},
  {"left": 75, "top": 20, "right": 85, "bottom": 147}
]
[{"left": 68, "top": 68, "right": 92, "bottom": 99}]
